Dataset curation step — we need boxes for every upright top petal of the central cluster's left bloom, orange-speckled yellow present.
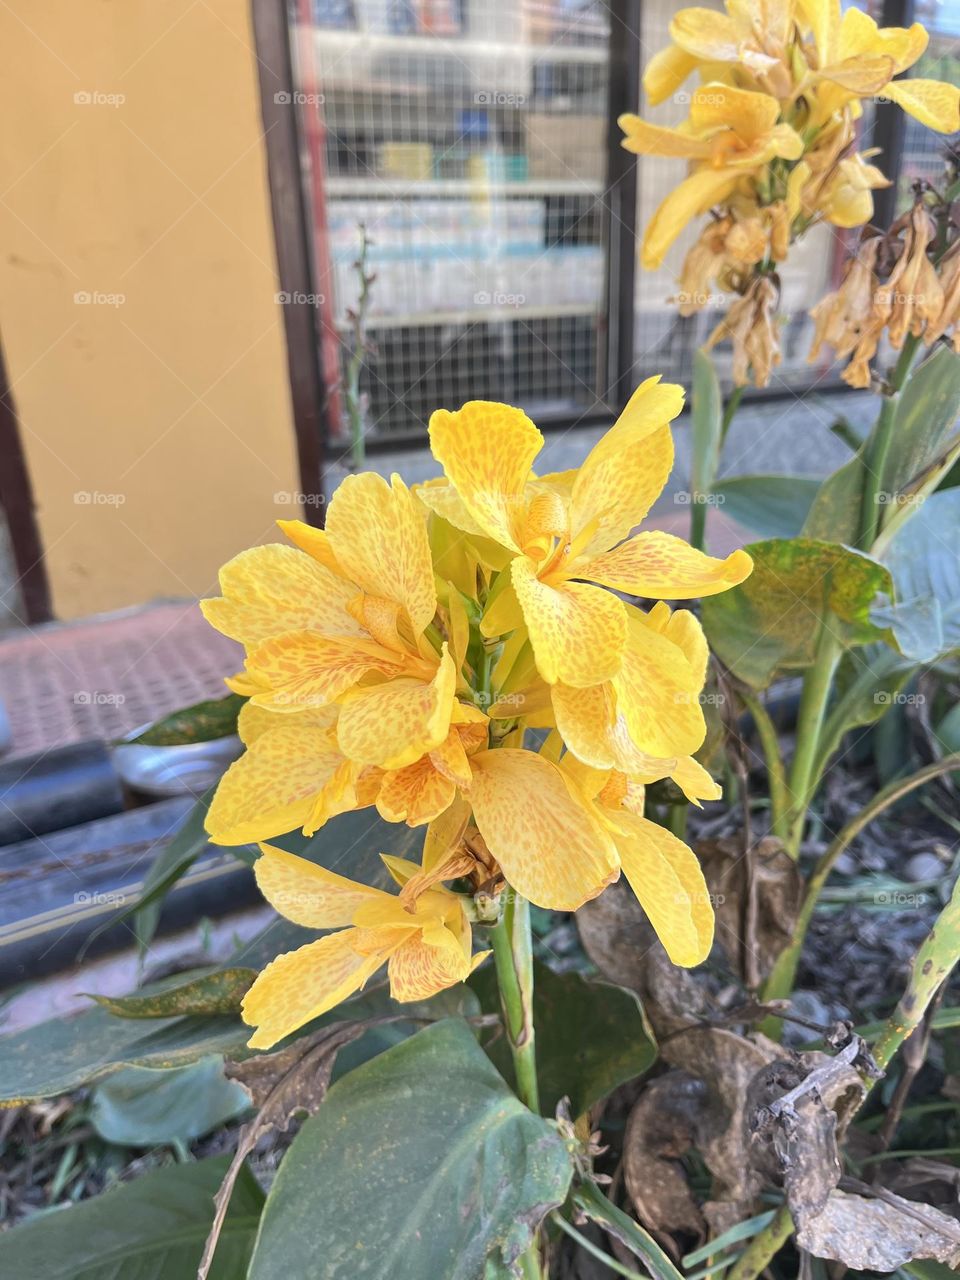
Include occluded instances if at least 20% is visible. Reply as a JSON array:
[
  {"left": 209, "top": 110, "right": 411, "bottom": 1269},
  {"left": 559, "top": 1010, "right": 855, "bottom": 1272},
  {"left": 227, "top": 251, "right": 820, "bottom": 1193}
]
[{"left": 326, "top": 471, "right": 436, "bottom": 635}]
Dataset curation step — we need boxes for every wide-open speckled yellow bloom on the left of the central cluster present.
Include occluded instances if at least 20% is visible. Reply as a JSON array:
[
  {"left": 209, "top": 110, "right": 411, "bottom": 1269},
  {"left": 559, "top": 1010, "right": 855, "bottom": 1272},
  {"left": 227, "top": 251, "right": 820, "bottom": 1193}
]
[{"left": 201, "top": 472, "right": 457, "bottom": 769}]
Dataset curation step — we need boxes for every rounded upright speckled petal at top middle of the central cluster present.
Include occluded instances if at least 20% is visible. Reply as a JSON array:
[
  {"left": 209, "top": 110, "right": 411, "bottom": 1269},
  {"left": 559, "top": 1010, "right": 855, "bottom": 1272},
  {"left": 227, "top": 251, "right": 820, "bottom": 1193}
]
[{"left": 430, "top": 401, "right": 543, "bottom": 550}]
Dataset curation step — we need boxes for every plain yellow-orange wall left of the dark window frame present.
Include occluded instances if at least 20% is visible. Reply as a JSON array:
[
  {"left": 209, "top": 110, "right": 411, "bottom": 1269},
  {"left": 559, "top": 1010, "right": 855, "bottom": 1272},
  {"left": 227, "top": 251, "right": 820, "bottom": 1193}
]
[{"left": 0, "top": 0, "right": 298, "bottom": 617}]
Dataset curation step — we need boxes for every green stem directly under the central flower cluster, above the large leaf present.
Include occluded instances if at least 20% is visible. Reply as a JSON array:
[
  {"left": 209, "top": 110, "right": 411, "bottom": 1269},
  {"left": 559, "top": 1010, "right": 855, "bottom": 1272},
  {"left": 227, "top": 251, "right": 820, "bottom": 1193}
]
[{"left": 490, "top": 888, "right": 540, "bottom": 1112}]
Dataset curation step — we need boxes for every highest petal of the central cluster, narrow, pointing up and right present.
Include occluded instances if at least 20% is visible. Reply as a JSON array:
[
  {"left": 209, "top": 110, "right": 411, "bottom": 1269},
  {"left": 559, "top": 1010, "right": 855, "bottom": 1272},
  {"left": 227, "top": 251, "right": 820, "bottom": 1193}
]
[{"left": 570, "top": 376, "right": 684, "bottom": 552}]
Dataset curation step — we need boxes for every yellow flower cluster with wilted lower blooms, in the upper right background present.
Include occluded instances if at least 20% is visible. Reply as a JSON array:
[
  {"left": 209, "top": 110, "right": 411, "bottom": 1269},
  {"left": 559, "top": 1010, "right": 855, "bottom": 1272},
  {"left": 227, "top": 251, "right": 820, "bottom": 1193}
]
[{"left": 620, "top": 0, "right": 960, "bottom": 387}]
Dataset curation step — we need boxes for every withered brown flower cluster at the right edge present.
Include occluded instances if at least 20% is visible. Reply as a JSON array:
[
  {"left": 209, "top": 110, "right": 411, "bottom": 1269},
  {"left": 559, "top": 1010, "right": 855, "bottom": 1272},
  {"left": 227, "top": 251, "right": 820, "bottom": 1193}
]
[{"left": 809, "top": 191, "right": 960, "bottom": 387}]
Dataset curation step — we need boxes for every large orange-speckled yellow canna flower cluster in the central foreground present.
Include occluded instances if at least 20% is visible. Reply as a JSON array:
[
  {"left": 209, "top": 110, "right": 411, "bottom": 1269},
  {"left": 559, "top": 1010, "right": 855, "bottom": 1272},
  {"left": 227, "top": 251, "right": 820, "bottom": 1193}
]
[{"left": 204, "top": 378, "right": 751, "bottom": 1046}]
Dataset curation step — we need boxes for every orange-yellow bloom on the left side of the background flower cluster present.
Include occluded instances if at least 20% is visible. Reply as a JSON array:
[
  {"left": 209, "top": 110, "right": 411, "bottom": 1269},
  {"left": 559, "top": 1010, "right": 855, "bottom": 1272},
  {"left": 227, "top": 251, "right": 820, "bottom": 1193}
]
[{"left": 617, "top": 81, "right": 804, "bottom": 270}]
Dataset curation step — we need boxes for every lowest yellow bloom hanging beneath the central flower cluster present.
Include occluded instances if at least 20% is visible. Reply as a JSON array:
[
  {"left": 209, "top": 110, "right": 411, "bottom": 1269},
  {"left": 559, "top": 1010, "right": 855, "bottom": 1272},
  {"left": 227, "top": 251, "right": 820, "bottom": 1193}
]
[{"left": 242, "top": 845, "right": 489, "bottom": 1048}]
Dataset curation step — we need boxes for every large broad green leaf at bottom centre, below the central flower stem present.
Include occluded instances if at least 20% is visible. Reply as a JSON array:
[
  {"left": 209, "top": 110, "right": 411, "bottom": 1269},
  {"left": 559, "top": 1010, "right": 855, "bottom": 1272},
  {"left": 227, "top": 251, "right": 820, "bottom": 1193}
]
[{"left": 248, "top": 1019, "right": 572, "bottom": 1280}]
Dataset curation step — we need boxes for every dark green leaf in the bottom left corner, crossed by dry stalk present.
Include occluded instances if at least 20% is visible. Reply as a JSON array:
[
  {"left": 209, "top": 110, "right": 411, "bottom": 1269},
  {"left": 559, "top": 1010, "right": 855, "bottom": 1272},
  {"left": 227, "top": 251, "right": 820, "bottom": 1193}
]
[{"left": 0, "top": 1157, "right": 264, "bottom": 1280}]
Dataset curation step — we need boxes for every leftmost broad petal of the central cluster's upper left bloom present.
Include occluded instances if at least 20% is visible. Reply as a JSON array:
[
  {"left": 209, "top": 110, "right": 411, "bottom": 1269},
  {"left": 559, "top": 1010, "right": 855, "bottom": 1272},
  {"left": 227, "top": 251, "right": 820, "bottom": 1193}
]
[{"left": 200, "top": 543, "right": 362, "bottom": 645}]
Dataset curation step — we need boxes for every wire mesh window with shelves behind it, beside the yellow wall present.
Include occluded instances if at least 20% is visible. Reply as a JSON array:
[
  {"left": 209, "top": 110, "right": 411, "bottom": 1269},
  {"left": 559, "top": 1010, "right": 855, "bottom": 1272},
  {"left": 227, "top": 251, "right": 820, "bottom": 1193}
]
[{"left": 291, "top": 0, "right": 609, "bottom": 442}]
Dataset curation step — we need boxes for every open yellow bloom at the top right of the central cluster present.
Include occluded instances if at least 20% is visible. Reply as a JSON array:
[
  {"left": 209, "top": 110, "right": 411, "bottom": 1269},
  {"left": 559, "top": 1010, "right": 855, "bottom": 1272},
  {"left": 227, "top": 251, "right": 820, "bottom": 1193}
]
[{"left": 417, "top": 376, "right": 751, "bottom": 689}]
